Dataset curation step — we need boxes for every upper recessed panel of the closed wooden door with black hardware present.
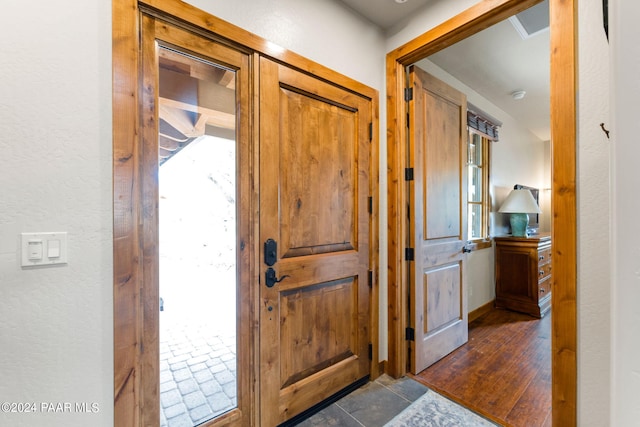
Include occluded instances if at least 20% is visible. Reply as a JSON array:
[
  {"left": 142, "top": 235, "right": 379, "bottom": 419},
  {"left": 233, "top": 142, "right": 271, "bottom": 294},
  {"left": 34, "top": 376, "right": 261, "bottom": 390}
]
[{"left": 278, "top": 88, "right": 358, "bottom": 257}]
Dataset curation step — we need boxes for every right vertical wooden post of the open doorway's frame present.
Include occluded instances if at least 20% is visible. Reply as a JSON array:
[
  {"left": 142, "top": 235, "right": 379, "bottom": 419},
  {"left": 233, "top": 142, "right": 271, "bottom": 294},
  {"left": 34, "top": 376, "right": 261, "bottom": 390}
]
[{"left": 549, "top": 0, "right": 578, "bottom": 426}]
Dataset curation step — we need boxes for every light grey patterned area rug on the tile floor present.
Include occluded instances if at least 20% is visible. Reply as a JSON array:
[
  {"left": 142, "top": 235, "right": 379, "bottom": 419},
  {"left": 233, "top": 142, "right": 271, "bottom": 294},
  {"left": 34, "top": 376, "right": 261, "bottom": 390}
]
[{"left": 385, "top": 390, "right": 498, "bottom": 427}]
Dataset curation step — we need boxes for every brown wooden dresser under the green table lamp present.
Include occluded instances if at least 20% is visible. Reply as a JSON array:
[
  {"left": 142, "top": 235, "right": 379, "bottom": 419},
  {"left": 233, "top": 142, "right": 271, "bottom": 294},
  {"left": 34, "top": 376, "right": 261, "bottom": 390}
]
[{"left": 494, "top": 233, "right": 551, "bottom": 317}]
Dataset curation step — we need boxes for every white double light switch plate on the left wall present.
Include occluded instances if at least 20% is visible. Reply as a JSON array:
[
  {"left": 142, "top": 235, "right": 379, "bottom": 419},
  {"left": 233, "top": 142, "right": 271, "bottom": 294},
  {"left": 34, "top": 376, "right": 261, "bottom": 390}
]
[{"left": 21, "top": 231, "right": 67, "bottom": 267}]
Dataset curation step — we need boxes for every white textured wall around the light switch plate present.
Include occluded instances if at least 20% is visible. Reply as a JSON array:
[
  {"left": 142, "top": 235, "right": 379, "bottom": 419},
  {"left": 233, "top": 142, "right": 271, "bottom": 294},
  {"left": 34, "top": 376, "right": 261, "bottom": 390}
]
[{"left": 0, "top": 0, "right": 113, "bottom": 426}]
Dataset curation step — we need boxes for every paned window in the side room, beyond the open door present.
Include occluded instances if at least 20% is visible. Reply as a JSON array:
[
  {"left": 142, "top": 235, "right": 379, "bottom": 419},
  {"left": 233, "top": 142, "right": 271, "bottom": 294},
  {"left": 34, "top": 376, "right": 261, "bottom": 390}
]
[{"left": 467, "top": 128, "right": 491, "bottom": 249}]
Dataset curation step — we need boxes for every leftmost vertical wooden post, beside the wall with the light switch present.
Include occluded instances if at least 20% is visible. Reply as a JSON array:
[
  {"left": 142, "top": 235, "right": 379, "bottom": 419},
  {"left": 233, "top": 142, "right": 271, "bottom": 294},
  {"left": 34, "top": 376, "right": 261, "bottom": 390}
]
[{"left": 112, "top": 0, "right": 141, "bottom": 426}]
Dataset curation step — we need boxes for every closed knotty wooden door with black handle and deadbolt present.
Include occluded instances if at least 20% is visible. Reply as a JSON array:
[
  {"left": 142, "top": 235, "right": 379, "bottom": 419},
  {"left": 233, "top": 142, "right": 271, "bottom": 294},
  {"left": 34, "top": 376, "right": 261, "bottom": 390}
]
[{"left": 259, "top": 58, "right": 372, "bottom": 426}]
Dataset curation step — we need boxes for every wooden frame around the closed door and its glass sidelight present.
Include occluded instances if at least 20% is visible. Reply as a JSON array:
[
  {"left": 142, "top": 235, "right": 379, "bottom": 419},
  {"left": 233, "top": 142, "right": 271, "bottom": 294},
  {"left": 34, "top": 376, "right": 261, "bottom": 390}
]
[{"left": 112, "top": 0, "right": 380, "bottom": 426}]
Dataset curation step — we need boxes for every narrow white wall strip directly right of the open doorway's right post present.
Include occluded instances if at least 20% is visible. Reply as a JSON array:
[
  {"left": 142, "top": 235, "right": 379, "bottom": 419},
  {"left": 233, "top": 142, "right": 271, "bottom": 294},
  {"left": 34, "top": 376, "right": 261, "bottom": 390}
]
[{"left": 577, "top": 0, "right": 612, "bottom": 427}]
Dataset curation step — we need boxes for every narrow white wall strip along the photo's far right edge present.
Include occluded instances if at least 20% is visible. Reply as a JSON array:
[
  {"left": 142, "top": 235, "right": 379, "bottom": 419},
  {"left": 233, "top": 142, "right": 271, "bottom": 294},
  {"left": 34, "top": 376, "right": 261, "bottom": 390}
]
[{"left": 608, "top": 0, "right": 640, "bottom": 426}]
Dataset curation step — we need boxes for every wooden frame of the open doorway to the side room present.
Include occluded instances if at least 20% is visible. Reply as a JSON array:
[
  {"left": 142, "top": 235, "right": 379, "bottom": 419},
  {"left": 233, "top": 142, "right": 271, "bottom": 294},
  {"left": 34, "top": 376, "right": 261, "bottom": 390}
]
[{"left": 386, "top": 0, "right": 578, "bottom": 426}]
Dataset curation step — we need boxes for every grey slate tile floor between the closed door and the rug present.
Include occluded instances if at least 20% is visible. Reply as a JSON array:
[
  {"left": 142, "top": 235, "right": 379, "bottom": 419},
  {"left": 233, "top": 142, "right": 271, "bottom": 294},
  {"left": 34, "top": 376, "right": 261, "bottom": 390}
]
[{"left": 297, "top": 375, "right": 428, "bottom": 427}]
